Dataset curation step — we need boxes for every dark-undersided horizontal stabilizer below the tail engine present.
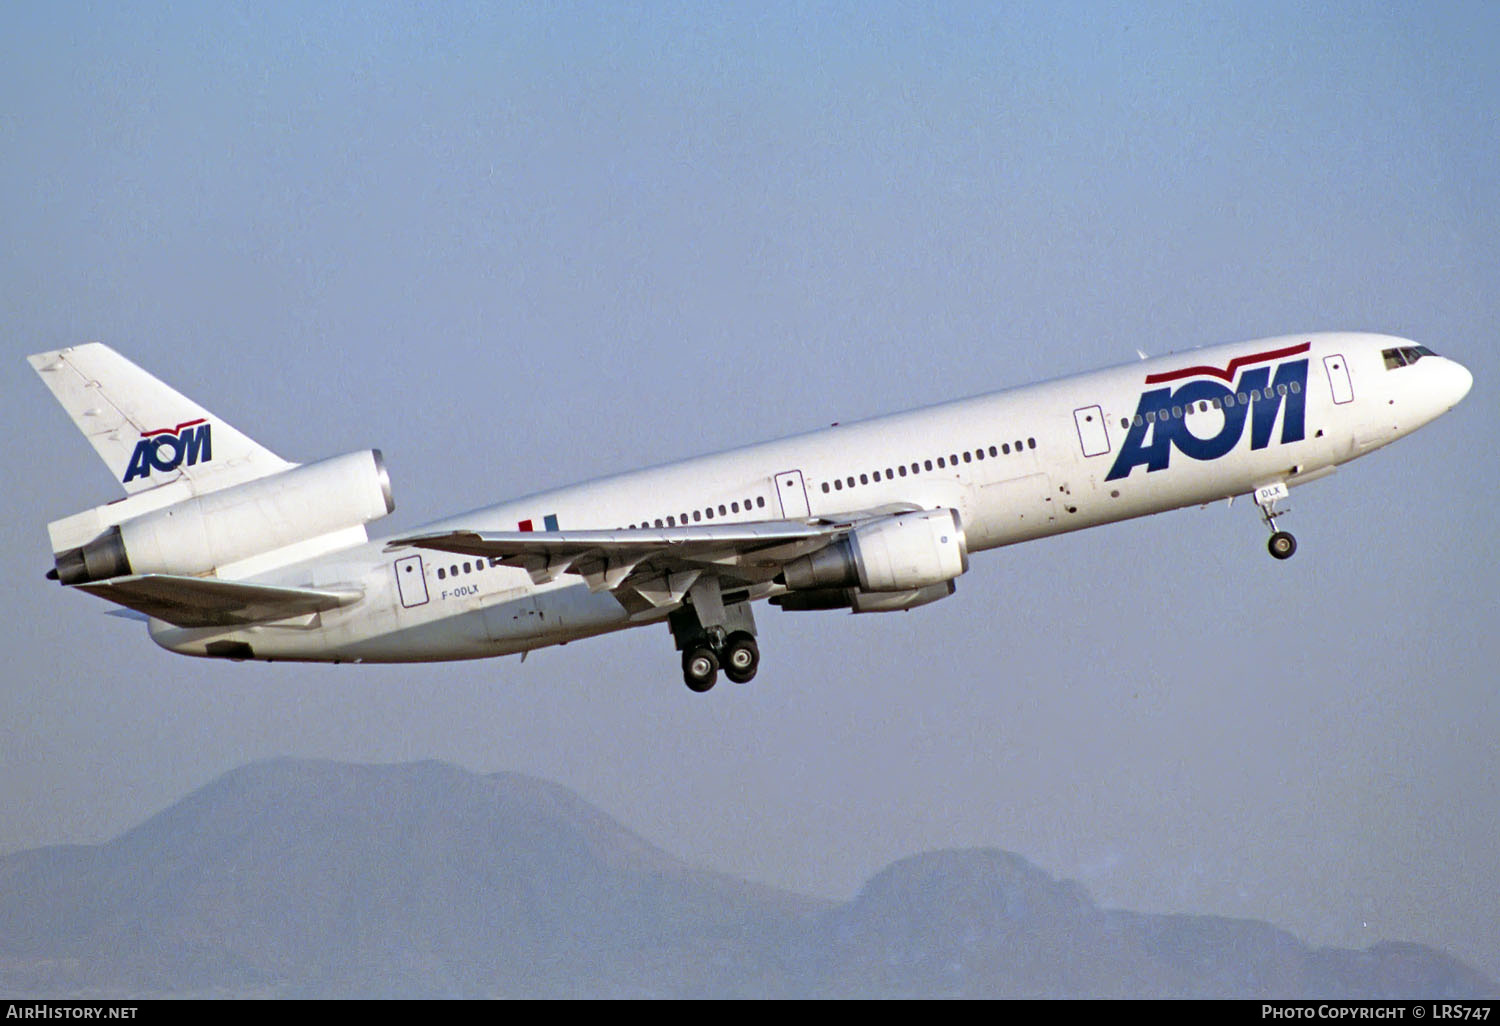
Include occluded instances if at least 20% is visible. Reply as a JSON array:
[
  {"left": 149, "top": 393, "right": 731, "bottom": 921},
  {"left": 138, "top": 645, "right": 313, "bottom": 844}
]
[{"left": 72, "top": 573, "right": 362, "bottom": 627}]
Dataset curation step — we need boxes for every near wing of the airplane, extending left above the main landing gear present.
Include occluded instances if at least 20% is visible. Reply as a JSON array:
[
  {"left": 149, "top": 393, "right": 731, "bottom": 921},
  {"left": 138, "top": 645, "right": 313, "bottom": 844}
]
[{"left": 386, "top": 506, "right": 914, "bottom": 615}]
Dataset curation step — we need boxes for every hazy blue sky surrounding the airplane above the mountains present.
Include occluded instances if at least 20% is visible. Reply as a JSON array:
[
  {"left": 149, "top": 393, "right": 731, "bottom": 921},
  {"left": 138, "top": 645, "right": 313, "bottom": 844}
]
[{"left": 0, "top": 3, "right": 1500, "bottom": 977}]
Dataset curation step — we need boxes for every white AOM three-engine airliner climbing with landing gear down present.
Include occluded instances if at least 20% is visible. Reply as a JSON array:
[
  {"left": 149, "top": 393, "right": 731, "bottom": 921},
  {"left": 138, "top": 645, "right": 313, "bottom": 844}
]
[{"left": 29, "top": 333, "right": 1473, "bottom": 692}]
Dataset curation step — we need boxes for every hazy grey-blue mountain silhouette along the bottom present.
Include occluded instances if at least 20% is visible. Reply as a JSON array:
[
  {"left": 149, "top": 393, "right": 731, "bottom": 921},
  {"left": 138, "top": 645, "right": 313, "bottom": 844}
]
[{"left": 0, "top": 759, "right": 1500, "bottom": 999}]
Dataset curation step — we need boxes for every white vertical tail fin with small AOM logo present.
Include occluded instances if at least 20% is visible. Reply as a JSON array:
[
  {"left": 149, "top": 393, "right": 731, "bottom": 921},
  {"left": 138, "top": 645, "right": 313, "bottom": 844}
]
[{"left": 27, "top": 342, "right": 294, "bottom": 495}]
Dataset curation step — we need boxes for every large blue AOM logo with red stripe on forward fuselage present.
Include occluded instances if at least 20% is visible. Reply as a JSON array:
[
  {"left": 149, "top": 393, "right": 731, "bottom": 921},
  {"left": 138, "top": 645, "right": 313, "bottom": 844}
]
[{"left": 1104, "top": 342, "right": 1313, "bottom": 482}]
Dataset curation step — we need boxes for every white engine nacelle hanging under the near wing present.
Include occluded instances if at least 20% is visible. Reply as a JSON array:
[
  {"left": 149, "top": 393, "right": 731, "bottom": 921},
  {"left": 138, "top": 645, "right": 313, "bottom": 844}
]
[{"left": 782, "top": 510, "right": 969, "bottom": 594}]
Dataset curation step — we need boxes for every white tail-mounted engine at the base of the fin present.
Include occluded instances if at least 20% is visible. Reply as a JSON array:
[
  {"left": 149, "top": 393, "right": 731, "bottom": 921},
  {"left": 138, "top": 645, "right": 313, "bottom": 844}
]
[{"left": 56, "top": 449, "right": 396, "bottom": 585}]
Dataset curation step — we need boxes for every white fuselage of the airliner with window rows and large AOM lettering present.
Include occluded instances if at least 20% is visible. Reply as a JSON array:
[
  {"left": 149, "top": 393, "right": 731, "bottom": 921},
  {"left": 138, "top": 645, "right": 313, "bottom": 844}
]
[{"left": 152, "top": 333, "right": 1472, "bottom": 662}]
